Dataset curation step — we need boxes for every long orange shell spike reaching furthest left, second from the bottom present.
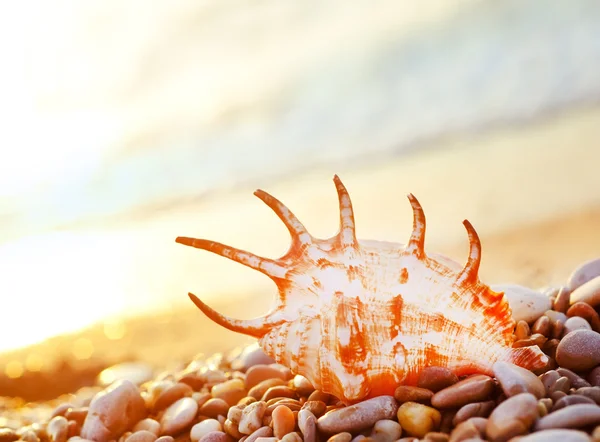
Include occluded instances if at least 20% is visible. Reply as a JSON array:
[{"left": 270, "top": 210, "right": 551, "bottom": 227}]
[{"left": 175, "top": 236, "right": 287, "bottom": 279}]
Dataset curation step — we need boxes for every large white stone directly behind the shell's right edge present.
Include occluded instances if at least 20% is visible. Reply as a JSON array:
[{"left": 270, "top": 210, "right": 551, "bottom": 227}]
[{"left": 491, "top": 284, "right": 552, "bottom": 324}]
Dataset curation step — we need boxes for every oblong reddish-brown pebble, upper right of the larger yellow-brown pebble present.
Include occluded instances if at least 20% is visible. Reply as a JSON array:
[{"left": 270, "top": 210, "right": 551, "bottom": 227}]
[{"left": 431, "top": 374, "right": 495, "bottom": 408}]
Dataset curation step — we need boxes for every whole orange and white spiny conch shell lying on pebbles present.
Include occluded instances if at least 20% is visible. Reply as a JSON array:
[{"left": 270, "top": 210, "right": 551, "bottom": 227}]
[{"left": 176, "top": 176, "right": 548, "bottom": 404}]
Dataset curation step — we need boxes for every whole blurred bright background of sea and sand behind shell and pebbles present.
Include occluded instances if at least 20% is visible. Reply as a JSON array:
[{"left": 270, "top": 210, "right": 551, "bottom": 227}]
[{"left": 0, "top": 0, "right": 600, "bottom": 404}]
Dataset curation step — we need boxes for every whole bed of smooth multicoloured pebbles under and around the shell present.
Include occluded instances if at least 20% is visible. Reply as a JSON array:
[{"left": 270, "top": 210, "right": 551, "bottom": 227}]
[{"left": 0, "top": 254, "right": 600, "bottom": 442}]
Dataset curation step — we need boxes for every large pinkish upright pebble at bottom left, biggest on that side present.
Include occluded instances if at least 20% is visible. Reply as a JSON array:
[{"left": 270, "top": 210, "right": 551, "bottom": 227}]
[{"left": 81, "top": 380, "right": 147, "bottom": 442}]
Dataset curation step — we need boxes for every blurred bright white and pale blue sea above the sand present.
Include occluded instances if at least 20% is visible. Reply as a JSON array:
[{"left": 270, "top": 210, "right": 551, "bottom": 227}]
[{"left": 0, "top": 0, "right": 600, "bottom": 349}]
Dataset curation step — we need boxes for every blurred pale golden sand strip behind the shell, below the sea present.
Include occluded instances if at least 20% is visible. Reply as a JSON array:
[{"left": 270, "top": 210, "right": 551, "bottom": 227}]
[{"left": 0, "top": 105, "right": 600, "bottom": 396}]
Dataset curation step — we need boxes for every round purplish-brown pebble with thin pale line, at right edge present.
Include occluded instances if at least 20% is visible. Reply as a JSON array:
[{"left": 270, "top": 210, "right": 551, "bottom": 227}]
[{"left": 556, "top": 330, "right": 600, "bottom": 371}]
